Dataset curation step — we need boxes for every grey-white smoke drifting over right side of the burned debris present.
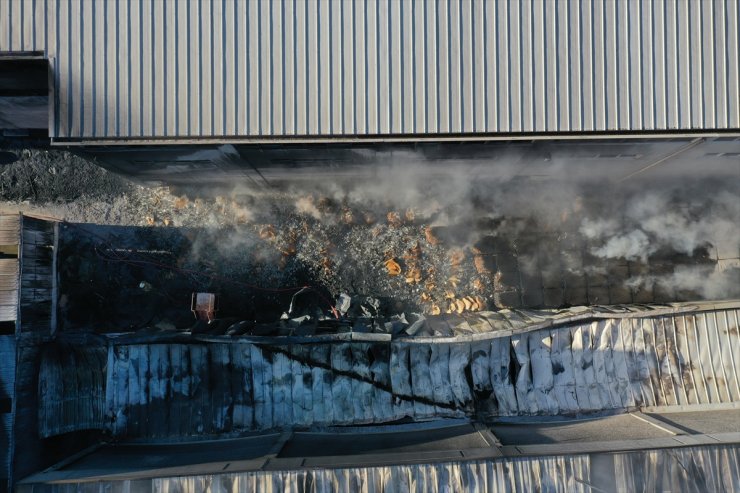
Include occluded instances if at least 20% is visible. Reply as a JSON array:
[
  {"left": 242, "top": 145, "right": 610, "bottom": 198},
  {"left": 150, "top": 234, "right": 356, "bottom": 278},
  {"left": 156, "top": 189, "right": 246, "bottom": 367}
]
[{"left": 272, "top": 148, "right": 740, "bottom": 304}]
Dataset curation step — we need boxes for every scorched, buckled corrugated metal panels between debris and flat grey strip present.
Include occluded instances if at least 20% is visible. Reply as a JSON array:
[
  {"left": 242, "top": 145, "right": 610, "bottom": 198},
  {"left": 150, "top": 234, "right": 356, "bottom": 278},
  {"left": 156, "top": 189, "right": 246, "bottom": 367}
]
[{"left": 106, "top": 309, "right": 740, "bottom": 436}]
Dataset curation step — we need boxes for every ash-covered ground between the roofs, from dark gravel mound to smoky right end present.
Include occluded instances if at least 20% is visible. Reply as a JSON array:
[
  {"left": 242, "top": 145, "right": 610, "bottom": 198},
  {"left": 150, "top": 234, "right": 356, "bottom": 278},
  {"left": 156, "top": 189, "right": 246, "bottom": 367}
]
[{"left": 0, "top": 146, "right": 740, "bottom": 331}]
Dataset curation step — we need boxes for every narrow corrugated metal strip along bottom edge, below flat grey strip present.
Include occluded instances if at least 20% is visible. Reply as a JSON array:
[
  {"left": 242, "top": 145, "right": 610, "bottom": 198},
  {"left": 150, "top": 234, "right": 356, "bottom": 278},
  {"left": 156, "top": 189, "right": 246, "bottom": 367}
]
[{"left": 13, "top": 446, "right": 740, "bottom": 493}]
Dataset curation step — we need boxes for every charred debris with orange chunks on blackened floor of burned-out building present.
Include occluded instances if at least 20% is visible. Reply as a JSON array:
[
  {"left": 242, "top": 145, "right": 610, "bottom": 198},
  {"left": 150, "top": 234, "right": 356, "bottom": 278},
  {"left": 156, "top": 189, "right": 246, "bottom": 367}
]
[{"left": 59, "top": 184, "right": 738, "bottom": 337}]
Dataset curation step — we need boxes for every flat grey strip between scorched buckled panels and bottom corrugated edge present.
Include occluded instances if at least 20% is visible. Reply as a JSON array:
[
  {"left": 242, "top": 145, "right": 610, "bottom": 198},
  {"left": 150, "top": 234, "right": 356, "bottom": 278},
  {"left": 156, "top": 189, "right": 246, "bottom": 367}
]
[{"left": 22, "top": 410, "right": 740, "bottom": 484}]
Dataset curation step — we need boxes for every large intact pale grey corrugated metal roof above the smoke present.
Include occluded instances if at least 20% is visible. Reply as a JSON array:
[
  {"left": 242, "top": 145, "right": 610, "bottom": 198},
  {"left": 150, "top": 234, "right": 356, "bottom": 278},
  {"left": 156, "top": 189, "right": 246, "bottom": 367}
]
[{"left": 0, "top": 0, "right": 740, "bottom": 139}]
